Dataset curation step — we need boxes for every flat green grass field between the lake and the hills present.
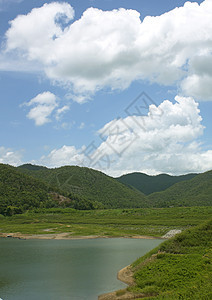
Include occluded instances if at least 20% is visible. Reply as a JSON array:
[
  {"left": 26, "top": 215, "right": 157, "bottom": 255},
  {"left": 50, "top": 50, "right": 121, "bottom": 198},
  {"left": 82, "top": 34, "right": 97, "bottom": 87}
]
[{"left": 0, "top": 207, "right": 212, "bottom": 237}]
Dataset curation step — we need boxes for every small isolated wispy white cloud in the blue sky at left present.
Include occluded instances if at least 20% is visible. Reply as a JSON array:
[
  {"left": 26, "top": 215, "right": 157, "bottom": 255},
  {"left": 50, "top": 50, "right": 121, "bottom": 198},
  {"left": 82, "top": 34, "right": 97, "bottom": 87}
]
[{"left": 24, "top": 92, "right": 58, "bottom": 126}]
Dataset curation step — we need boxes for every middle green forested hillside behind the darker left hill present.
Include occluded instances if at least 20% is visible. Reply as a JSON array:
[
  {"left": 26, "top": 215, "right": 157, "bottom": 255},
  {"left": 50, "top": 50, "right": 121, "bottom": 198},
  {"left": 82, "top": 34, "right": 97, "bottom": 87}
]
[{"left": 18, "top": 164, "right": 148, "bottom": 208}]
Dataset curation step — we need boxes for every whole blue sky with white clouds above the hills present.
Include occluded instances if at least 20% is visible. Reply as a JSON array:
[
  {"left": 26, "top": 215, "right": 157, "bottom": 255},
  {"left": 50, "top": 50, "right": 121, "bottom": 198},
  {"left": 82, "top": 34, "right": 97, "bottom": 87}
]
[{"left": 0, "top": 0, "right": 212, "bottom": 177}]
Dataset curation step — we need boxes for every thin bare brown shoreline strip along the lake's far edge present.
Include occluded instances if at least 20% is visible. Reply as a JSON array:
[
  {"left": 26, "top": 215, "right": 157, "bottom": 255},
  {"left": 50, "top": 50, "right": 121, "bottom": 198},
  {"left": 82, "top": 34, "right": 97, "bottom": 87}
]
[{"left": 0, "top": 232, "right": 162, "bottom": 240}]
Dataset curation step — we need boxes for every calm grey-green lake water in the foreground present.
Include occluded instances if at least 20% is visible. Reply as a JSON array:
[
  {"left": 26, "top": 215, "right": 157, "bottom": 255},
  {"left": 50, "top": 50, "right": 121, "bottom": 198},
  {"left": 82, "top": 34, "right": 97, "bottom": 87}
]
[{"left": 0, "top": 238, "right": 161, "bottom": 300}]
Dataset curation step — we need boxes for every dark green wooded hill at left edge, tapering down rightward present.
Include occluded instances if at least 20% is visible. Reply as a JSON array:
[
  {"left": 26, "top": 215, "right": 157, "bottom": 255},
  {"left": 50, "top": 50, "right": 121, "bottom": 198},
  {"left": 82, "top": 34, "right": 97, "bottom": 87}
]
[{"left": 0, "top": 164, "right": 103, "bottom": 216}]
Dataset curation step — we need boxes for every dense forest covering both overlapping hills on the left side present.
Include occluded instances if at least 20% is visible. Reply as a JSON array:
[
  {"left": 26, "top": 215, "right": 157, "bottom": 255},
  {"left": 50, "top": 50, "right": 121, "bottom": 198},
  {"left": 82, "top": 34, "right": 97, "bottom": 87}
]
[{"left": 0, "top": 164, "right": 147, "bottom": 215}]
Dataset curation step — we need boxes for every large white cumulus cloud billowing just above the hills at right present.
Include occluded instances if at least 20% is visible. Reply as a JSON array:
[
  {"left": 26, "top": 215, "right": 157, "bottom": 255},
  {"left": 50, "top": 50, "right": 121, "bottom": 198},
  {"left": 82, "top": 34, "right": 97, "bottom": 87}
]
[{"left": 39, "top": 96, "right": 212, "bottom": 176}]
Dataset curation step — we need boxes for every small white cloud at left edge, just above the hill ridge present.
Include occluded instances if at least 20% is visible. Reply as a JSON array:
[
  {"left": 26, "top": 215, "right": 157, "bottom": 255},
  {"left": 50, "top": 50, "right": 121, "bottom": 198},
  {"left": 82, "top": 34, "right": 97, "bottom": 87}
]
[{"left": 0, "top": 146, "right": 22, "bottom": 166}]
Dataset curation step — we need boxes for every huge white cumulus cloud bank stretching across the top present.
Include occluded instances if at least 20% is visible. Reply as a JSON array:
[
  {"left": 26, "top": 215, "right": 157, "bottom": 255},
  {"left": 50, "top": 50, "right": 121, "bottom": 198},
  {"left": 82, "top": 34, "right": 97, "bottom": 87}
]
[{"left": 3, "top": 0, "right": 212, "bottom": 101}]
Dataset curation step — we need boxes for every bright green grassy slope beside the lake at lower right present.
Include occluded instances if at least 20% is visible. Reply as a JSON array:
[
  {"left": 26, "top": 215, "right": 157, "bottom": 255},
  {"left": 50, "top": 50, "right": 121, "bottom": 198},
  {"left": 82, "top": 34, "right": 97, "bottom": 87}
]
[{"left": 128, "top": 220, "right": 212, "bottom": 300}]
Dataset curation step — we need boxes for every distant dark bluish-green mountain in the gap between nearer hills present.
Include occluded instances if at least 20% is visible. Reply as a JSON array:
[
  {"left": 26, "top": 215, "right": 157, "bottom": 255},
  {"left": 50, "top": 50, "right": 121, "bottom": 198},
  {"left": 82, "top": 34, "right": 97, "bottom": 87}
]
[{"left": 116, "top": 173, "right": 197, "bottom": 195}]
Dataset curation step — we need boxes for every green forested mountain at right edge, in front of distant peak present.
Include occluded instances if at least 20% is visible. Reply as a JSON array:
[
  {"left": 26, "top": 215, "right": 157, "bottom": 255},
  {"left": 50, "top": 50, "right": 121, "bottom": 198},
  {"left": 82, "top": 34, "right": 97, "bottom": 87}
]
[{"left": 148, "top": 170, "right": 212, "bottom": 207}]
